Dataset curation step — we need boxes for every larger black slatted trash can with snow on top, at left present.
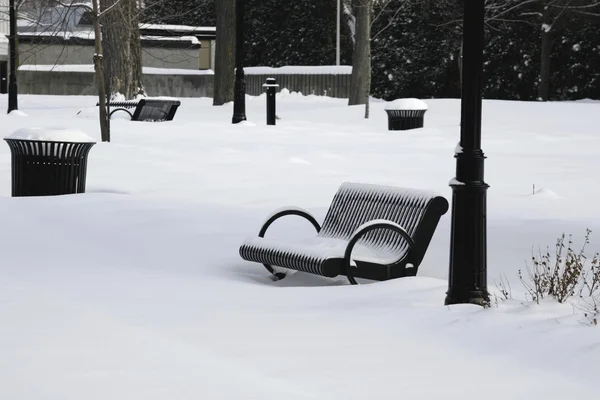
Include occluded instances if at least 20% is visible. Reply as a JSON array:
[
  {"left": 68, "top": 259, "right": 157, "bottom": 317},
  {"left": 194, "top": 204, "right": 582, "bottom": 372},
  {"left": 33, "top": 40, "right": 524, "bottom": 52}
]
[{"left": 4, "top": 137, "right": 96, "bottom": 197}]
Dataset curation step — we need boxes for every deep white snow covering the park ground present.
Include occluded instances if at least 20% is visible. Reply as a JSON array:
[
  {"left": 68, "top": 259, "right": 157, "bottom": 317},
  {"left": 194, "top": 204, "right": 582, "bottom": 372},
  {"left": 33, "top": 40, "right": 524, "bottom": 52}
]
[{"left": 0, "top": 93, "right": 600, "bottom": 400}]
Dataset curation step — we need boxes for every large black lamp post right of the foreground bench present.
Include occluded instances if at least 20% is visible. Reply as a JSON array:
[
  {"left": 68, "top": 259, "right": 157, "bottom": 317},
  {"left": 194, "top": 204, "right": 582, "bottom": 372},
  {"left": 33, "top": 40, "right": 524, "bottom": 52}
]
[{"left": 446, "top": 0, "right": 489, "bottom": 305}]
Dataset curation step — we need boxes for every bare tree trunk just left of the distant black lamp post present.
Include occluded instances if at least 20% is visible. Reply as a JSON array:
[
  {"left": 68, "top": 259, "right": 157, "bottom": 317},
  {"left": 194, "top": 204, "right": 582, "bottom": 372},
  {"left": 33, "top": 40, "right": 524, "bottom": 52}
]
[{"left": 213, "top": 0, "right": 235, "bottom": 106}]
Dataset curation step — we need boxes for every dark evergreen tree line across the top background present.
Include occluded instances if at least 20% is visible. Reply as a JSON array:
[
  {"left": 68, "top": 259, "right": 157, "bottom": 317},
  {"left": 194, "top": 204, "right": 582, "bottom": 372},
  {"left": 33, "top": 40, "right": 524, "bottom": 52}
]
[{"left": 146, "top": 0, "right": 600, "bottom": 100}]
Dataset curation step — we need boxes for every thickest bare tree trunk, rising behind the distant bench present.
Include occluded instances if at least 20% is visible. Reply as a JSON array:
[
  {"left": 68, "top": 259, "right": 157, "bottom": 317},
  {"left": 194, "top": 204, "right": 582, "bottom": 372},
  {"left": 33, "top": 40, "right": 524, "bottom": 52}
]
[{"left": 100, "top": 0, "right": 143, "bottom": 99}]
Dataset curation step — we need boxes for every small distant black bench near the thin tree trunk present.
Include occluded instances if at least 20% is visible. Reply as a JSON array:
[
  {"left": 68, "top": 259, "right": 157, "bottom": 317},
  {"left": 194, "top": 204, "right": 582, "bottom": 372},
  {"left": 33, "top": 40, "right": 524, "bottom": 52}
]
[{"left": 96, "top": 98, "right": 181, "bottom": 121}]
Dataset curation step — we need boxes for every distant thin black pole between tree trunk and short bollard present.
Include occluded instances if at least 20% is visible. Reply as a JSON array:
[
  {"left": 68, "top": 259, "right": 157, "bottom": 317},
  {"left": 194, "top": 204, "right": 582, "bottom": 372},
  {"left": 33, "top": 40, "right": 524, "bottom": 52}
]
[{"left": 232, "top": 0, "right": 246, "bottom": 124}]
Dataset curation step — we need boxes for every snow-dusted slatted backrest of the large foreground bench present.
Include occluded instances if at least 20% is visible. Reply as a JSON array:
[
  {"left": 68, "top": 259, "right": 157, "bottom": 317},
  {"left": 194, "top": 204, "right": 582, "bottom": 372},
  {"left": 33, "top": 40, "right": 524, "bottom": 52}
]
[{"left": 319, "top": 183, "right": 448, "bottom": 262}]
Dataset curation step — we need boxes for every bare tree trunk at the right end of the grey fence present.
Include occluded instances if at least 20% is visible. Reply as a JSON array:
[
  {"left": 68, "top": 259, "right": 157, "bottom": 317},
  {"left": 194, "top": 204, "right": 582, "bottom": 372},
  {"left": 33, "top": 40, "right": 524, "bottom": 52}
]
[{"left": 348, "top": 0, "right": 372, "bottom": 111}]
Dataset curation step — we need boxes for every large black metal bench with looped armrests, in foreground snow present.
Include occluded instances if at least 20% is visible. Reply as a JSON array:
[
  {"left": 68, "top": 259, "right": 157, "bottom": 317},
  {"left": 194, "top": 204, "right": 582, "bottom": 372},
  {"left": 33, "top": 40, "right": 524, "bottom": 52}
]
[{"left": 239, "top": 183, "right": 448, "bottom": 284}]
